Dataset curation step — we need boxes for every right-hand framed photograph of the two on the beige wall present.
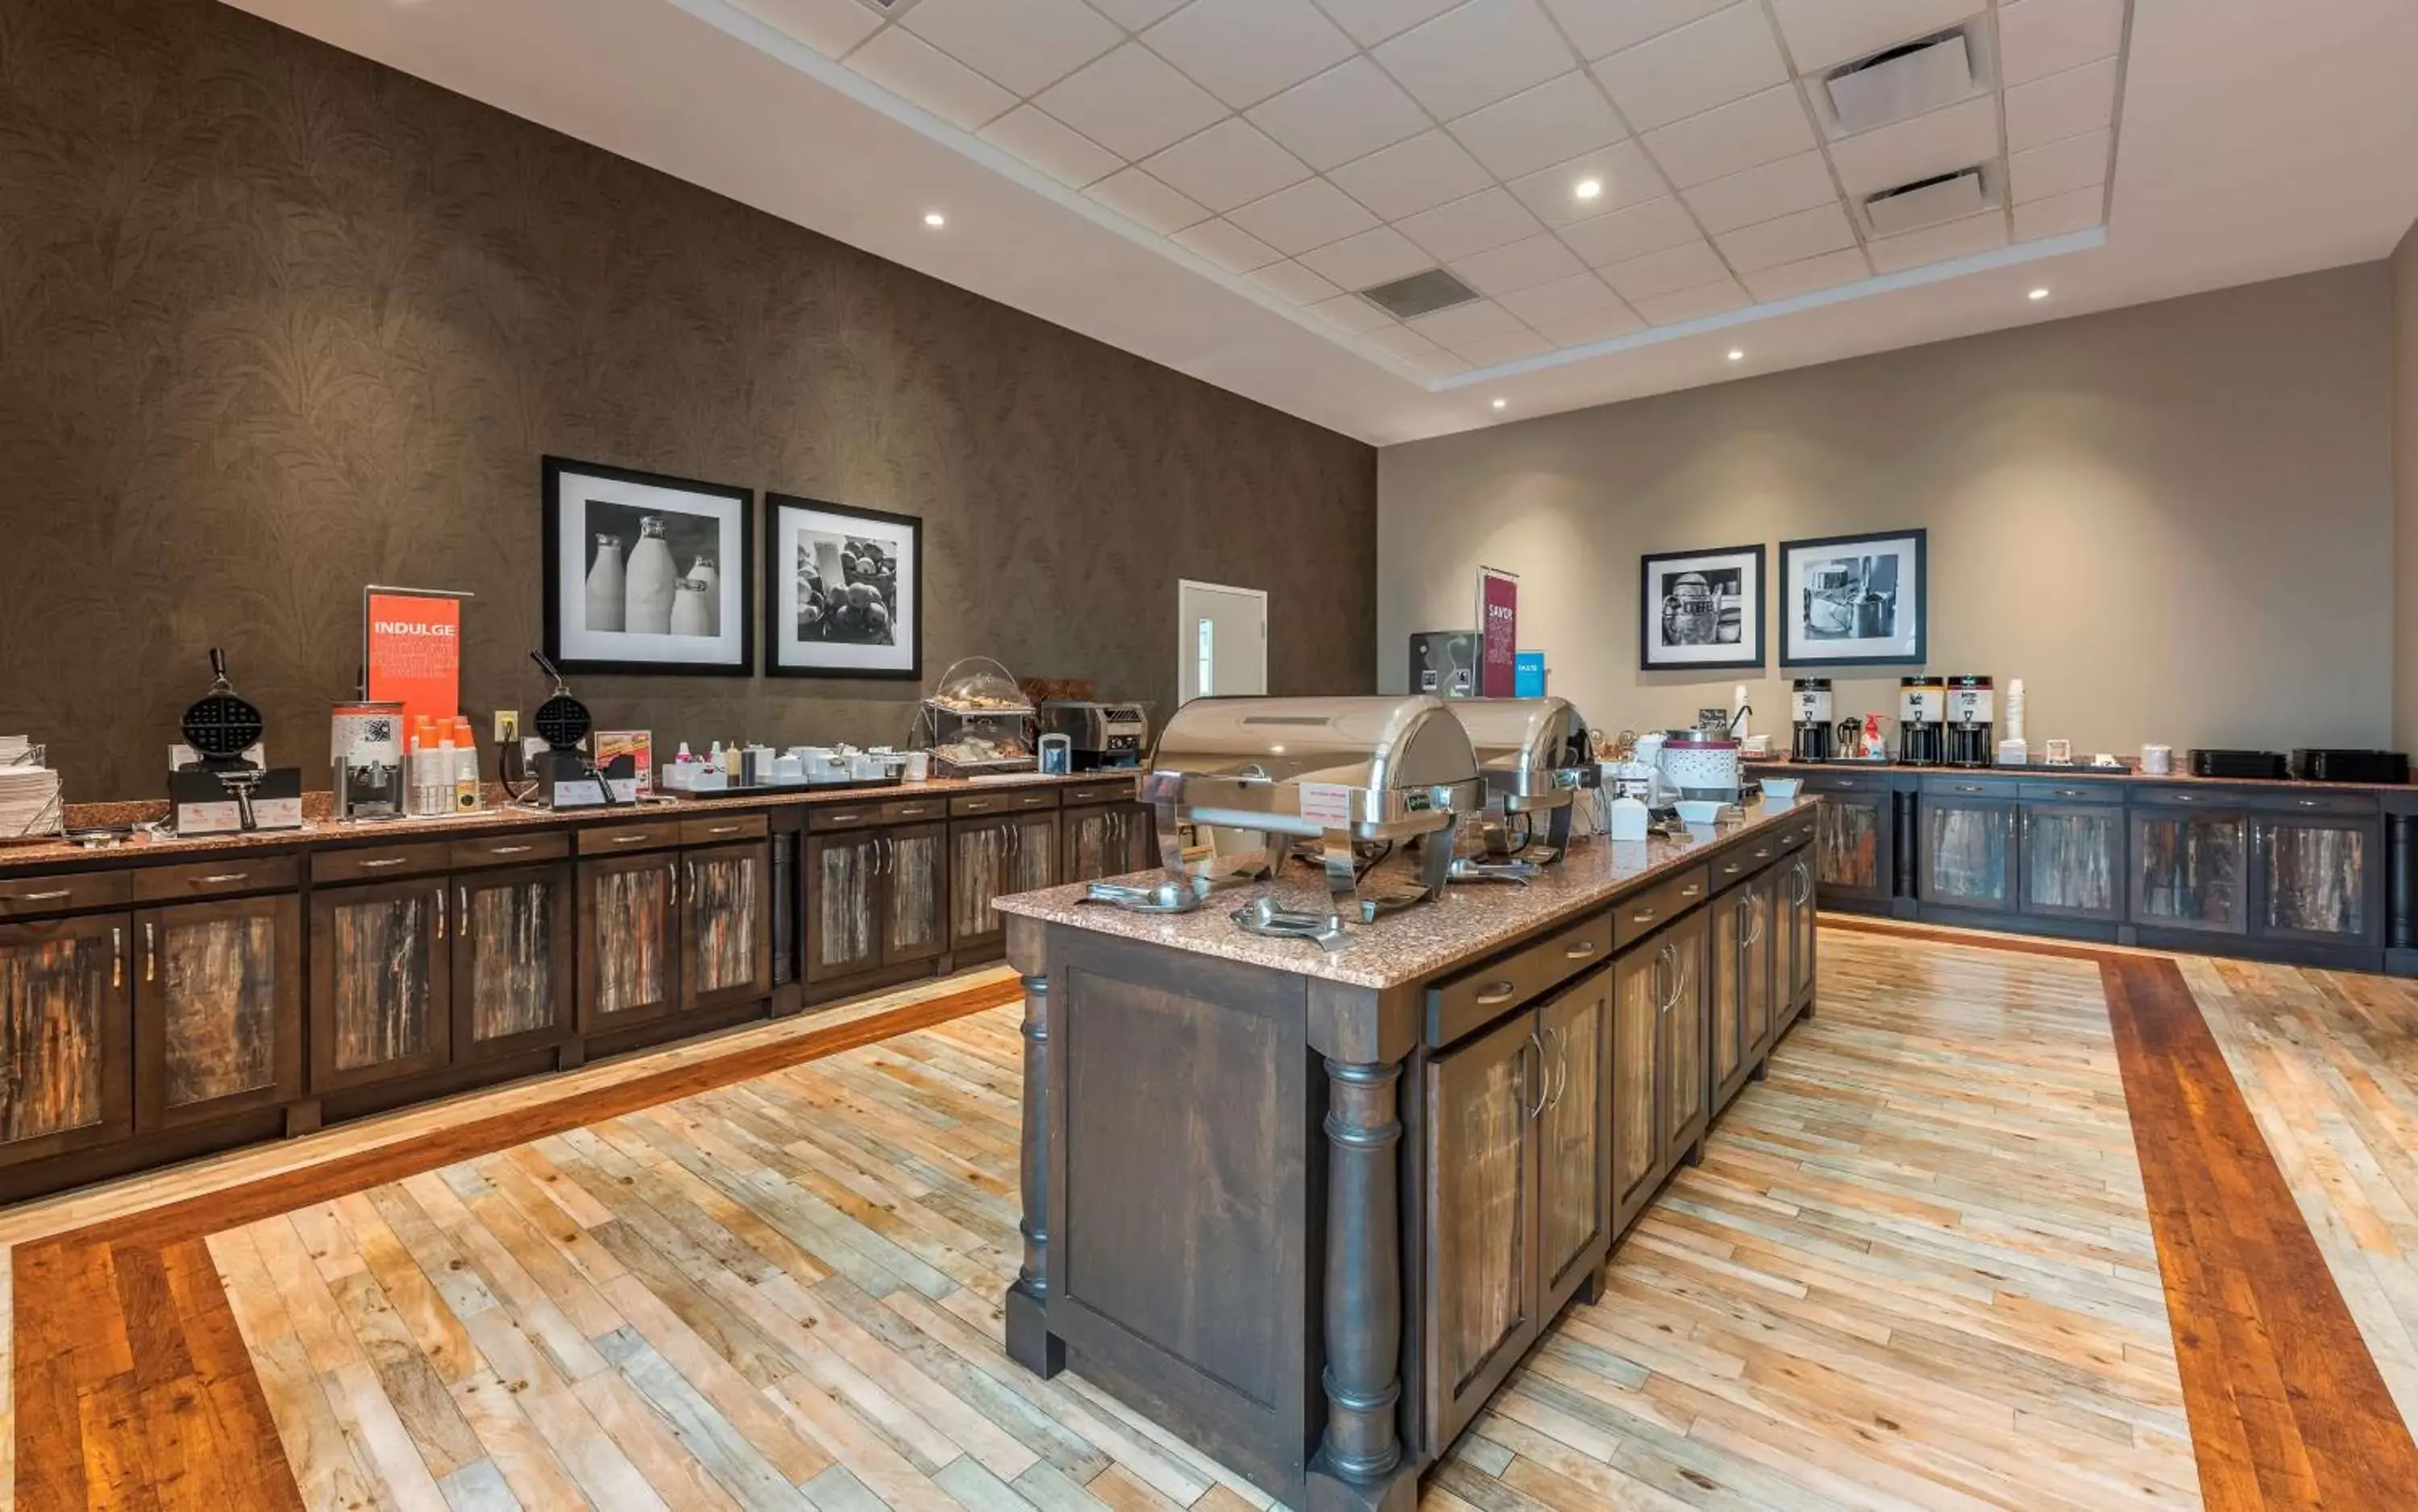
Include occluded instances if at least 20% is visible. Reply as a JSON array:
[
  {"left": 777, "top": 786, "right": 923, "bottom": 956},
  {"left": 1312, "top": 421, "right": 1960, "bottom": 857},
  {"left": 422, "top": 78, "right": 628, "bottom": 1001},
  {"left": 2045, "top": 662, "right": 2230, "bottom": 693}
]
[{"left": 1780, "top": 530, "right": 1930, "bottom": 667}]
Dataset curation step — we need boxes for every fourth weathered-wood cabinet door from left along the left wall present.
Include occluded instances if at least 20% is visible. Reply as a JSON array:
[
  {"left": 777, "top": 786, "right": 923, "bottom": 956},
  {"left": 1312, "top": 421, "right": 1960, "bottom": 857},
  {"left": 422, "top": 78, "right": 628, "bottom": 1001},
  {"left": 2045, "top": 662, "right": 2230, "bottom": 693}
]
[{"left": 452, "top": 866, "right": 575, "bottom": 1062}]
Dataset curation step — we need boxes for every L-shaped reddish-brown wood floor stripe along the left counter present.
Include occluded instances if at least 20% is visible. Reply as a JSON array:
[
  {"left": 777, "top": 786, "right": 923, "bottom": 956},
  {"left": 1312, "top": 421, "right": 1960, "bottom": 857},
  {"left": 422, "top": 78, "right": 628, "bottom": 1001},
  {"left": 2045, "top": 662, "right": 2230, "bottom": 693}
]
[{"left": 15, "top": 980, "right": 1020, "bottom": 1512}]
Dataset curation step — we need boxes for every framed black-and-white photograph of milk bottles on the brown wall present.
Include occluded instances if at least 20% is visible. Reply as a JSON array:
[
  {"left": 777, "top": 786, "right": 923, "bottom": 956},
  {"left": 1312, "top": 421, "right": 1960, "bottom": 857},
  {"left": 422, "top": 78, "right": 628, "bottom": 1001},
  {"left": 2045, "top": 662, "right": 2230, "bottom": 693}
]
[{"left": 544, "top": 457, "right": 754, "bottom": 677}]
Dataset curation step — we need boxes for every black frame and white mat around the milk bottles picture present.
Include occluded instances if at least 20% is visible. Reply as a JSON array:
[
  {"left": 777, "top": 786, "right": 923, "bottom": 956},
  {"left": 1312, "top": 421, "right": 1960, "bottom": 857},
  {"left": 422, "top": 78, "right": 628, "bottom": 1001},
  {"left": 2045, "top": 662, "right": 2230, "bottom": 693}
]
[{"left": 539, "top": 455, "right": 757, "bottom": 677}]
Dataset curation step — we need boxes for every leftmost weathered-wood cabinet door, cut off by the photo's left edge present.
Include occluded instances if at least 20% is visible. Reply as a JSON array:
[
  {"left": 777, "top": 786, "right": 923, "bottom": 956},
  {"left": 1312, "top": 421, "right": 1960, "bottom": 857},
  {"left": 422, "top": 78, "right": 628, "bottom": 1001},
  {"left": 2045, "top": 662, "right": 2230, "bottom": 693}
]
[{"left": 0, "top": 915, "right": 133, "bottom": 1164}]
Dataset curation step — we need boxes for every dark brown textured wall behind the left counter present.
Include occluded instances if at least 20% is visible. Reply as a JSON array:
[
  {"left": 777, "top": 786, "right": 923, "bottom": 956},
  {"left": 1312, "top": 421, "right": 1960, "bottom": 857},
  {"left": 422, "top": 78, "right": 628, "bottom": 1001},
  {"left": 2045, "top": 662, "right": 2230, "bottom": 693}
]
[{"left": 0, "top": 0, "right": 1376, "bottom": 801}]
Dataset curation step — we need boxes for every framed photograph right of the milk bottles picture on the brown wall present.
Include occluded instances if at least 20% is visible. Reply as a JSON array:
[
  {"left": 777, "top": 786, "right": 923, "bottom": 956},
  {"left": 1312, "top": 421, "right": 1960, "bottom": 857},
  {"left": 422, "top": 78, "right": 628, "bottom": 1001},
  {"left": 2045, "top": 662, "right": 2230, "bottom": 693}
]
[{"left": 764, "top": 493, "right": 924, "bottom": 677}]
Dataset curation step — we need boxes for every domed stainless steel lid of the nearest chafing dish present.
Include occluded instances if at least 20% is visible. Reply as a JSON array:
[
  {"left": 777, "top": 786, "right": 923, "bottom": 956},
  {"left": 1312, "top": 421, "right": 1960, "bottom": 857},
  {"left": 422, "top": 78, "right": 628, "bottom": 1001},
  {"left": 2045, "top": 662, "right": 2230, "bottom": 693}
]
[{"left": 1141, "top": 696, "right": 1485, "bottom": 840}]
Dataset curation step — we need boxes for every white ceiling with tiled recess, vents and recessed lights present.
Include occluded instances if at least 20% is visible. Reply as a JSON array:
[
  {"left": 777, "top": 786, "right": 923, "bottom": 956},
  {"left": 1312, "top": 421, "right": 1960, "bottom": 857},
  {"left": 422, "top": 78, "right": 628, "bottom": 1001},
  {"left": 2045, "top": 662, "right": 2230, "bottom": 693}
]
[{"left": 230, "top": 0, "right": 2418, "bottom": 442}]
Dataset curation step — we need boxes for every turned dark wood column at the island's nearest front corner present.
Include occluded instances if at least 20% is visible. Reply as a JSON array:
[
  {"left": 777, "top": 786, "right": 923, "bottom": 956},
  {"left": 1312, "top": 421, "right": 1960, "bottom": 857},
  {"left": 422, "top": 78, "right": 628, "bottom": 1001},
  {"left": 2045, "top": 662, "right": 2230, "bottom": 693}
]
[{"left": 1311, "top": 1060, "right": 1417, "bottom": 1512}]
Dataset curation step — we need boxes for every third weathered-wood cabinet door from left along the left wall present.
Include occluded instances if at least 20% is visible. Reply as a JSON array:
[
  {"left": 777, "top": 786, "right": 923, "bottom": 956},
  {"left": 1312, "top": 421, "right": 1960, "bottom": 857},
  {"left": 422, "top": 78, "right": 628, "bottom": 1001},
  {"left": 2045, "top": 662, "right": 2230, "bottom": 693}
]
[{"left": 310, "top": 874, "right": 452, "bottom": 1091}]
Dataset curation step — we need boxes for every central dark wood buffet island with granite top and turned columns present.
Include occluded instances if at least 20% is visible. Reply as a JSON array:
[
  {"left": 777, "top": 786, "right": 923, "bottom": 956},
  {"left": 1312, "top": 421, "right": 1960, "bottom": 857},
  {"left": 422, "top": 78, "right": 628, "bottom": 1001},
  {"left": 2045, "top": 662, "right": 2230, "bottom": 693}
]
[{"left": 999, "top": 788, "right": 1821, "bottom": 1510}]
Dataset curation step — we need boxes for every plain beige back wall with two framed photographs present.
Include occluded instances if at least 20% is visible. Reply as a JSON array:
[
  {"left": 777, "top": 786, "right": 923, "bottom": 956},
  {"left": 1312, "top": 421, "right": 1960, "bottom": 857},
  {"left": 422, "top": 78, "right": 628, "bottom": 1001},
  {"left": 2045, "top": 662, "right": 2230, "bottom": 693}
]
[{"left": 1378, "top": 267, "right": 2418, "bottom": 752}]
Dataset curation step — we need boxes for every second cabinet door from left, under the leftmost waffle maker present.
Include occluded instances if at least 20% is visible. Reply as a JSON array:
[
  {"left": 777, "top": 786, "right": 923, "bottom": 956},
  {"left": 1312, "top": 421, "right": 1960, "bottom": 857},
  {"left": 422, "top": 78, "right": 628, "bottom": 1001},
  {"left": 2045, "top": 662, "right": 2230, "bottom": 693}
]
[{"left": 133, "top": 893, "right": 302, "bottom": 1132}]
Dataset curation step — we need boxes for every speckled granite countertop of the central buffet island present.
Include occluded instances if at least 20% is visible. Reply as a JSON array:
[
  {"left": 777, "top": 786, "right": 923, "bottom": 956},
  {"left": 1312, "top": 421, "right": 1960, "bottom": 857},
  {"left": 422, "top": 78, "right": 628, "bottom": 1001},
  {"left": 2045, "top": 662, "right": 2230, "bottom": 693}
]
[{"left": 994, "top": 796, "right": 1821, "bottom": 990}]
